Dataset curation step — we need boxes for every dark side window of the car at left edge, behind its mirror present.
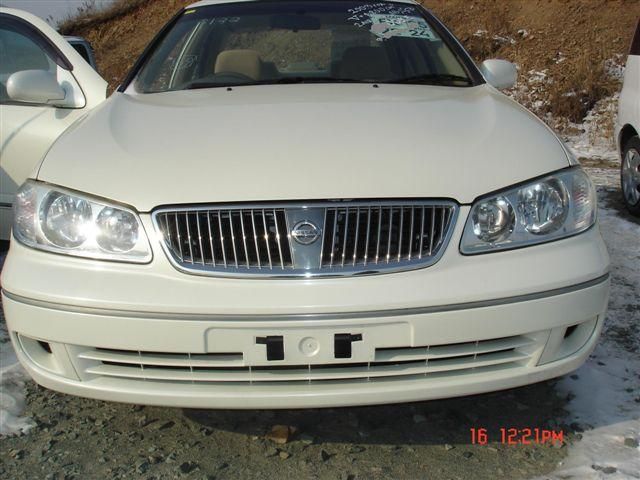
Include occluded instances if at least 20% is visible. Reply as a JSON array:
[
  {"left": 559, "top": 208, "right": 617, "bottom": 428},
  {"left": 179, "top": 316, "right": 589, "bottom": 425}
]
[{"left": 0, "top": 22, "right": 57, "bottom": 102}]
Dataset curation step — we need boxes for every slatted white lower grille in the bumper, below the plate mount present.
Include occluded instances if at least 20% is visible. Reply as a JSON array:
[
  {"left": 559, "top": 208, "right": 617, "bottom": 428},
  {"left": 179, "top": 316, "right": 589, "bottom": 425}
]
[{"left": 76, "top": 335, "right": 536, "bottom": 384}]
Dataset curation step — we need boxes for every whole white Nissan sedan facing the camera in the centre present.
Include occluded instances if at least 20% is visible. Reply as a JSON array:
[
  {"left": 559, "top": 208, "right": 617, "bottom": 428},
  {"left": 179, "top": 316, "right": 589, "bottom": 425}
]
[{"left": 2, "top": 0, "right": 609, "bottom": 408}]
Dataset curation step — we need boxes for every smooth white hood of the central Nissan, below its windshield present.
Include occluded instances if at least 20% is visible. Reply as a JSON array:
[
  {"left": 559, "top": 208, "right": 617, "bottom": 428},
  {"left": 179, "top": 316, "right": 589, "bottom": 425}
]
[{"left": 38, "top": 84, "right": 568, "bottom": 211}]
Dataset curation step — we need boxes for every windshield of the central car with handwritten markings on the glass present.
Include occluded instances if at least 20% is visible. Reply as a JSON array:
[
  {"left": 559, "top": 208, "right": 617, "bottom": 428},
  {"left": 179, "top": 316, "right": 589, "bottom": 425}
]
[{"left": 135, "top": 0, "right": 473, "bottom": 93}]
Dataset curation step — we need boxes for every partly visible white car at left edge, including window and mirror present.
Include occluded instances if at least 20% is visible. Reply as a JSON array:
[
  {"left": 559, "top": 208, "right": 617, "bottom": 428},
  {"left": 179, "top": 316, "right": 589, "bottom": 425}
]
[{"left": 0, "top": 8, "right": 107, "bottom": 240}]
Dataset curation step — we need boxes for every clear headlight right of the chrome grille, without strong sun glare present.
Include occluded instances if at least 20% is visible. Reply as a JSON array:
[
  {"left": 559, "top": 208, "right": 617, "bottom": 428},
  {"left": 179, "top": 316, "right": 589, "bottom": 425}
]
[{"left": 460, "top": 168, "right": 596, "bottom": 255}]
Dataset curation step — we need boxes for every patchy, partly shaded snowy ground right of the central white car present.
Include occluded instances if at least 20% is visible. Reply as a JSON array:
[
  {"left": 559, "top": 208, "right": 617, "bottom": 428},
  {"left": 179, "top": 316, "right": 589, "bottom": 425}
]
[{"left": 544, "top": 169, "right": 640, "bottom": 480}]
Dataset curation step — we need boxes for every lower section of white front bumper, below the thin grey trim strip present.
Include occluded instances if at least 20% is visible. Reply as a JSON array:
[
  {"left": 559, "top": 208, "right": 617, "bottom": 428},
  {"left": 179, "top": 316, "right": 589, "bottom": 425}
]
[{"left": 3, "top": 277, "right": 609, "bottom": 408}]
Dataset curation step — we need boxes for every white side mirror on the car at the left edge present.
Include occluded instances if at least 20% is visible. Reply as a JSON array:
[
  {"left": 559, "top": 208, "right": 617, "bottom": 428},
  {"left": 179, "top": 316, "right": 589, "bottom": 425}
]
[{"left": 7, "top": 70, "right": 66, "bottom": 105}]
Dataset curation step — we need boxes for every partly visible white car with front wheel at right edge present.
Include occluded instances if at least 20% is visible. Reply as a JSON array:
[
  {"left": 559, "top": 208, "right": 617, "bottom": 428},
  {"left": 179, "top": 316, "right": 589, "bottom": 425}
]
[{"left": 616, "top": 21, "right": 640, "bottom": 216}]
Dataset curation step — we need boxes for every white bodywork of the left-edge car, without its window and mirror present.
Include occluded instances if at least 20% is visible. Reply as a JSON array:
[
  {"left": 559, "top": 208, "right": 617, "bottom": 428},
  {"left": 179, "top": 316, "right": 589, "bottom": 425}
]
[{"left": 0, "top": 8, "right": 107, "bottom": 240}]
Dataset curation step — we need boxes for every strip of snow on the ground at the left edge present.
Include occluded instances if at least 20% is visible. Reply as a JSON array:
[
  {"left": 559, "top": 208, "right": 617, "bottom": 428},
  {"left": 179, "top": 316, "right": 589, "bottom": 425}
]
[{"left": 0, "top": 252, "right": 33, "bottom": 435}]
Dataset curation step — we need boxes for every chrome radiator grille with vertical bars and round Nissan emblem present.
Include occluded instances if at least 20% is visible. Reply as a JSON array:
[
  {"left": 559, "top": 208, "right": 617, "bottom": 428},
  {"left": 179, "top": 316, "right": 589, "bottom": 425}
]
[{"left": 153, "top": 200, "right": 458, "bottom": 277}]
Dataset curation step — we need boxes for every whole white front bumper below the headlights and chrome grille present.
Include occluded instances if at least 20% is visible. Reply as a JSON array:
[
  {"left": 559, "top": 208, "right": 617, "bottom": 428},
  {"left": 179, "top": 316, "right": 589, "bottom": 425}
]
[{"left": 2, "top": 216, "right": 609, "bottom": 408}]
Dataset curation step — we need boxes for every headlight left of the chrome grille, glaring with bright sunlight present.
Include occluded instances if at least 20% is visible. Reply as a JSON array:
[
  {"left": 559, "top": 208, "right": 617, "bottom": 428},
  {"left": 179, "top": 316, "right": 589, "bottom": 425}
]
[{"left": 13, "top": 181, "right": 151, "bottom": 263}]
